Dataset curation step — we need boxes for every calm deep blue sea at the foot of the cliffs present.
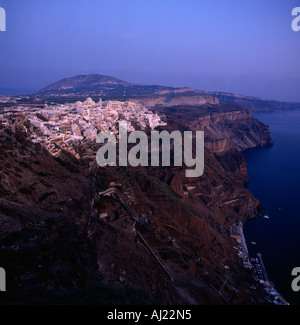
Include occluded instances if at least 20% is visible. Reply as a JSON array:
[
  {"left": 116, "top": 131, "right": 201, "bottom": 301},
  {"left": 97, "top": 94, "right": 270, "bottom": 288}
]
[{"left": 244, "top": 109, "right": 300, "bottom": 305}]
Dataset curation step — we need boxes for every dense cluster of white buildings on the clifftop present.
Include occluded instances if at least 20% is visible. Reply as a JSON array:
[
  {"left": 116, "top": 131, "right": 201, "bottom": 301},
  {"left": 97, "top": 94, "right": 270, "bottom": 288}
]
[{"left": 0, "top": 98, "right": 166, "bottom": 159}]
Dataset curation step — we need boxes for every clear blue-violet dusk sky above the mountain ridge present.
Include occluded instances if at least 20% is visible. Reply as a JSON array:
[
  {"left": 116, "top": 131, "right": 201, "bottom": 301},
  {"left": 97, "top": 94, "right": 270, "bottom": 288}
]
[{"left": 0, "top": 0, "right": 300, "bottom": 102}]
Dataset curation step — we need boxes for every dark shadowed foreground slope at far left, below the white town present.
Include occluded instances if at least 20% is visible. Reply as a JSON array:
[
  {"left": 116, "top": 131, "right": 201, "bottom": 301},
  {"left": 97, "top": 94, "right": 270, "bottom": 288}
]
[{"left": 0, "top": 119, "right": 98, "bottom": 304}]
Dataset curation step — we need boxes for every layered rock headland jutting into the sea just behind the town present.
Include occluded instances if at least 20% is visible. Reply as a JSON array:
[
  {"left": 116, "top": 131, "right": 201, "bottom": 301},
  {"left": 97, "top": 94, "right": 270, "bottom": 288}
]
[{"left": 158, "top": 105, "right": 273, "bottom": 152}]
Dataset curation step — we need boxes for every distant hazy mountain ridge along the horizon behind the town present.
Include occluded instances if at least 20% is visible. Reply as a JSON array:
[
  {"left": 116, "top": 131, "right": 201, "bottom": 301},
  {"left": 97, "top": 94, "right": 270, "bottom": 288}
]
[{"left": 34, "top": 74, "right": 300, "bottom": 111}]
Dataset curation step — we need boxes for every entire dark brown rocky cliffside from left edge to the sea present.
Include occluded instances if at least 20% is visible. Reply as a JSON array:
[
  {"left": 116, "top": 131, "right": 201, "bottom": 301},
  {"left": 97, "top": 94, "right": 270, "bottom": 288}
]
[{"left": 0, "top": 105, "right": 272, "bottom": 304}]
